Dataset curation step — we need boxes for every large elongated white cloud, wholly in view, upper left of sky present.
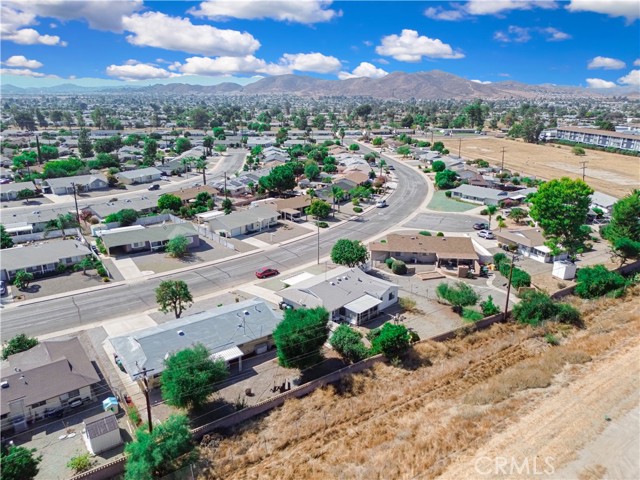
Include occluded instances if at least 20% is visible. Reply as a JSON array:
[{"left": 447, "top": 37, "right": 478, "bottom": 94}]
[{"left": 123, "top": 12, "right": 260, "bottom": 56}]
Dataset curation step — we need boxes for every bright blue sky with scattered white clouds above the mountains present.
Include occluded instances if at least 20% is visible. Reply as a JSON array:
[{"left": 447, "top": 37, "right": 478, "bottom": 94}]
[{"left": 0, "top": 0, "right": 640, "bottom": 88}]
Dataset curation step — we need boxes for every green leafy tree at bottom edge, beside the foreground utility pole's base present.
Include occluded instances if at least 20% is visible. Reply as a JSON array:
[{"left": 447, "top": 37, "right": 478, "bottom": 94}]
[{"left": 124, "top": 415, "right": 197, "bottom": 480}]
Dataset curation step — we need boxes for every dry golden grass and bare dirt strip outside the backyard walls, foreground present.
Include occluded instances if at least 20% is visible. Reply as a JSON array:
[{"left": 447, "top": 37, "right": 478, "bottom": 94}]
[{"left": 198, "top": 289, "right": 640, "bottom": 479}]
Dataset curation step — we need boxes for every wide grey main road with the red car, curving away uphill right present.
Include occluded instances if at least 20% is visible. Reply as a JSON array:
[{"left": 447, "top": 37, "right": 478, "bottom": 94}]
[{"left": 0, "top": 154, "right": 427, "bottom": 338}]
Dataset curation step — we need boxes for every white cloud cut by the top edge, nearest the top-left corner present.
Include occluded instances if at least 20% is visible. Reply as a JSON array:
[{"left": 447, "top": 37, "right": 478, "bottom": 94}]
[{"left": 5, "top": 0, "right": 143, "bottom": 32}]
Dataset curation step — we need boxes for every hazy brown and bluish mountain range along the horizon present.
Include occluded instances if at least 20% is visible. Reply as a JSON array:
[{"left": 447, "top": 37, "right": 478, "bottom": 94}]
[{"left": 1, "top": 70, "right": 640, "bottom": 100}]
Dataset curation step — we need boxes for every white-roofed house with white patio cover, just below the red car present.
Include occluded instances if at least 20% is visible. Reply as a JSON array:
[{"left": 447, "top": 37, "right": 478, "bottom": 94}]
[{"left": 277, "top": 267, "right": 398, "bottom": 325}]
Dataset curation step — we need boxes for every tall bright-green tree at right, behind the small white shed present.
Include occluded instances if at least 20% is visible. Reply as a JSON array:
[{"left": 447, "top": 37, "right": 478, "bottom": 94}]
[{"left": 530, "top": 177, "right": 593, "bottom": 254}]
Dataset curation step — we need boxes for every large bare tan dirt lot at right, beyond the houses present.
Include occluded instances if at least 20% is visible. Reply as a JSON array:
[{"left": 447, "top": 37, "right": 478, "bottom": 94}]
[{"left": 444, "top": 136, "right": 640, "bottom": 197}]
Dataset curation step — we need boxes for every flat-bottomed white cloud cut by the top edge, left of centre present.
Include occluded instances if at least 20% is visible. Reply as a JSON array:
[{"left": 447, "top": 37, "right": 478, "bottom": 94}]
[{"left": 189, "top": 0, "right": 342, "bottom": 24}]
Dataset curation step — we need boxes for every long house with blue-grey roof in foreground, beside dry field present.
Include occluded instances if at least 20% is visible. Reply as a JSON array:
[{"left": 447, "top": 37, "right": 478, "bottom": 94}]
[{"left": 109, "top": 298, "right": 282, "bottom": 384}]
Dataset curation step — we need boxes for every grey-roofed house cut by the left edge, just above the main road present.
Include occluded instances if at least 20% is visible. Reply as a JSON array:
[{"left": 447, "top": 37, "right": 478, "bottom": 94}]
[{"left": 0, "top": 240, "right": 91, "bottom": 281}]
